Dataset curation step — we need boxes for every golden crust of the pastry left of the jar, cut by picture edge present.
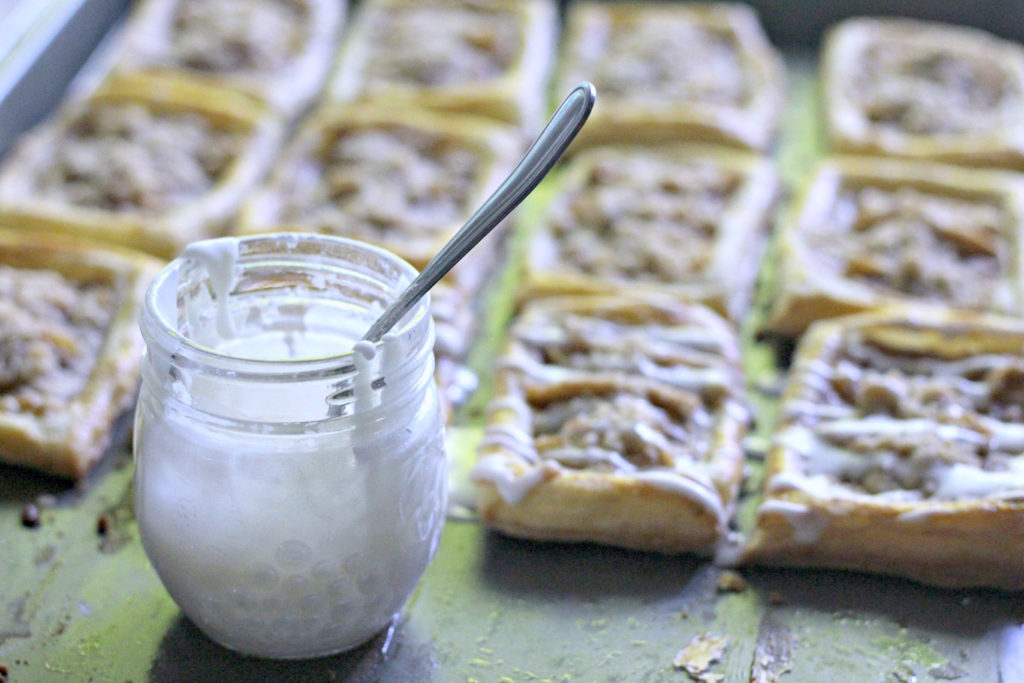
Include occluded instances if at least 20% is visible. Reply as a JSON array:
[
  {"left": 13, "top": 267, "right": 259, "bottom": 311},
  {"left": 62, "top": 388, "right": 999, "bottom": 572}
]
[{"left": 0, "top": 228, "right": 160, "bottom": 478}]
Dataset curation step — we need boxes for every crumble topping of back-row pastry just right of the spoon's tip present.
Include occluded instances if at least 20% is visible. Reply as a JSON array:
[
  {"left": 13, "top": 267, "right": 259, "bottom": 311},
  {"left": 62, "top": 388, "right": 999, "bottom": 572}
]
[{"left": 579, "top": 13, "right": 748, "bottom": 106}]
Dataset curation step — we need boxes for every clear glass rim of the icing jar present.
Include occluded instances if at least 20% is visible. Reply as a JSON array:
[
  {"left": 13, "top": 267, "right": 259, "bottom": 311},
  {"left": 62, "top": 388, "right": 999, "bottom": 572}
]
[{"left": 139, "top": 231, "right": 430, "bottom": 379}]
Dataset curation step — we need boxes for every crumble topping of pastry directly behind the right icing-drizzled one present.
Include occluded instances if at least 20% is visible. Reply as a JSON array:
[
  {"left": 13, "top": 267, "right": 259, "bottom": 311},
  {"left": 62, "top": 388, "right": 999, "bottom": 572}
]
[{"left": 807, "top": 187, "right": 1010, "bottom": 309}]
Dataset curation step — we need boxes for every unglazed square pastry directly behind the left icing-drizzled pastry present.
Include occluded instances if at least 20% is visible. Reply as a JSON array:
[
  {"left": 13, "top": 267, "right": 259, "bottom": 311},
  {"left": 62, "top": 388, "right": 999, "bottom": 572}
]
[{"left": 522, "top": 145, "right": 777, "bottom": 319}]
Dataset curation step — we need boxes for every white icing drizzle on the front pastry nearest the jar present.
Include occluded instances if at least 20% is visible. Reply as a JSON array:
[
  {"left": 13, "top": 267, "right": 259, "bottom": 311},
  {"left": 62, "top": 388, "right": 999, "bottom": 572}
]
[{"left": 470, "top": 301, "right": 749, "bottom": 526}]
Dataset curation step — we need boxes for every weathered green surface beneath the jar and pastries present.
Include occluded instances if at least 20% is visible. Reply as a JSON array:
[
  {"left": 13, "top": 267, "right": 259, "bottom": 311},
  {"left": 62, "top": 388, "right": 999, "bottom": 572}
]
[{"left": 0, "top": 56, "right": 1024, "bottom": 683}]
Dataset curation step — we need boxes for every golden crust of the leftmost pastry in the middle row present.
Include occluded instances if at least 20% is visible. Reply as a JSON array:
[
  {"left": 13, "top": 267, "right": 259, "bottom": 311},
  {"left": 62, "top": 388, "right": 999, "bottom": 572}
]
[{"left": 0, "top": 75, "right": 283, "bottom": 258}]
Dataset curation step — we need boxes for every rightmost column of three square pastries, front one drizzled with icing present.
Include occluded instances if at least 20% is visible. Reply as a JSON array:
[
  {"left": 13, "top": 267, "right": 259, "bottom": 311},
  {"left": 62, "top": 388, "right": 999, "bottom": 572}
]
[{"left": 742, "top": 18, "right": 1024, "bottom": 590}]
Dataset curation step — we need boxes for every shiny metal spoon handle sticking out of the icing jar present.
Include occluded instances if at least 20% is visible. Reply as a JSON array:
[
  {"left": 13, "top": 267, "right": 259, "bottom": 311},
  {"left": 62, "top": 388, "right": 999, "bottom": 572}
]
[{"left": 362, "top": 81, "right": 597, "bottom": 342}]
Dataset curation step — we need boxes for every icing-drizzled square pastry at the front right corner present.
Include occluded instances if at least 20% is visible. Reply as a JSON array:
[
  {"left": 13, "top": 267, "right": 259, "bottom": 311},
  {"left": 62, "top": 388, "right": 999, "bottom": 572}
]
[{"left": 745, "top": 307, "right": 1024, "bottom": 590}]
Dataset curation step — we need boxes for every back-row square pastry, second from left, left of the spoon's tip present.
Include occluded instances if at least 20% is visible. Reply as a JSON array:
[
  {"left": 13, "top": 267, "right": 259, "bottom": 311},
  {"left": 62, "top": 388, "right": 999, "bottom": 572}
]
[{"left": 328, "top": 0, "right": 558, "bottom": 134}]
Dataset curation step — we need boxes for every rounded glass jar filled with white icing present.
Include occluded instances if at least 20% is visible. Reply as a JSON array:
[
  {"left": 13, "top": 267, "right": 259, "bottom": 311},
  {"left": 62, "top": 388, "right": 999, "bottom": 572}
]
[{"left": 134, "top": 233, "right": 447, "bottom": 658}]
